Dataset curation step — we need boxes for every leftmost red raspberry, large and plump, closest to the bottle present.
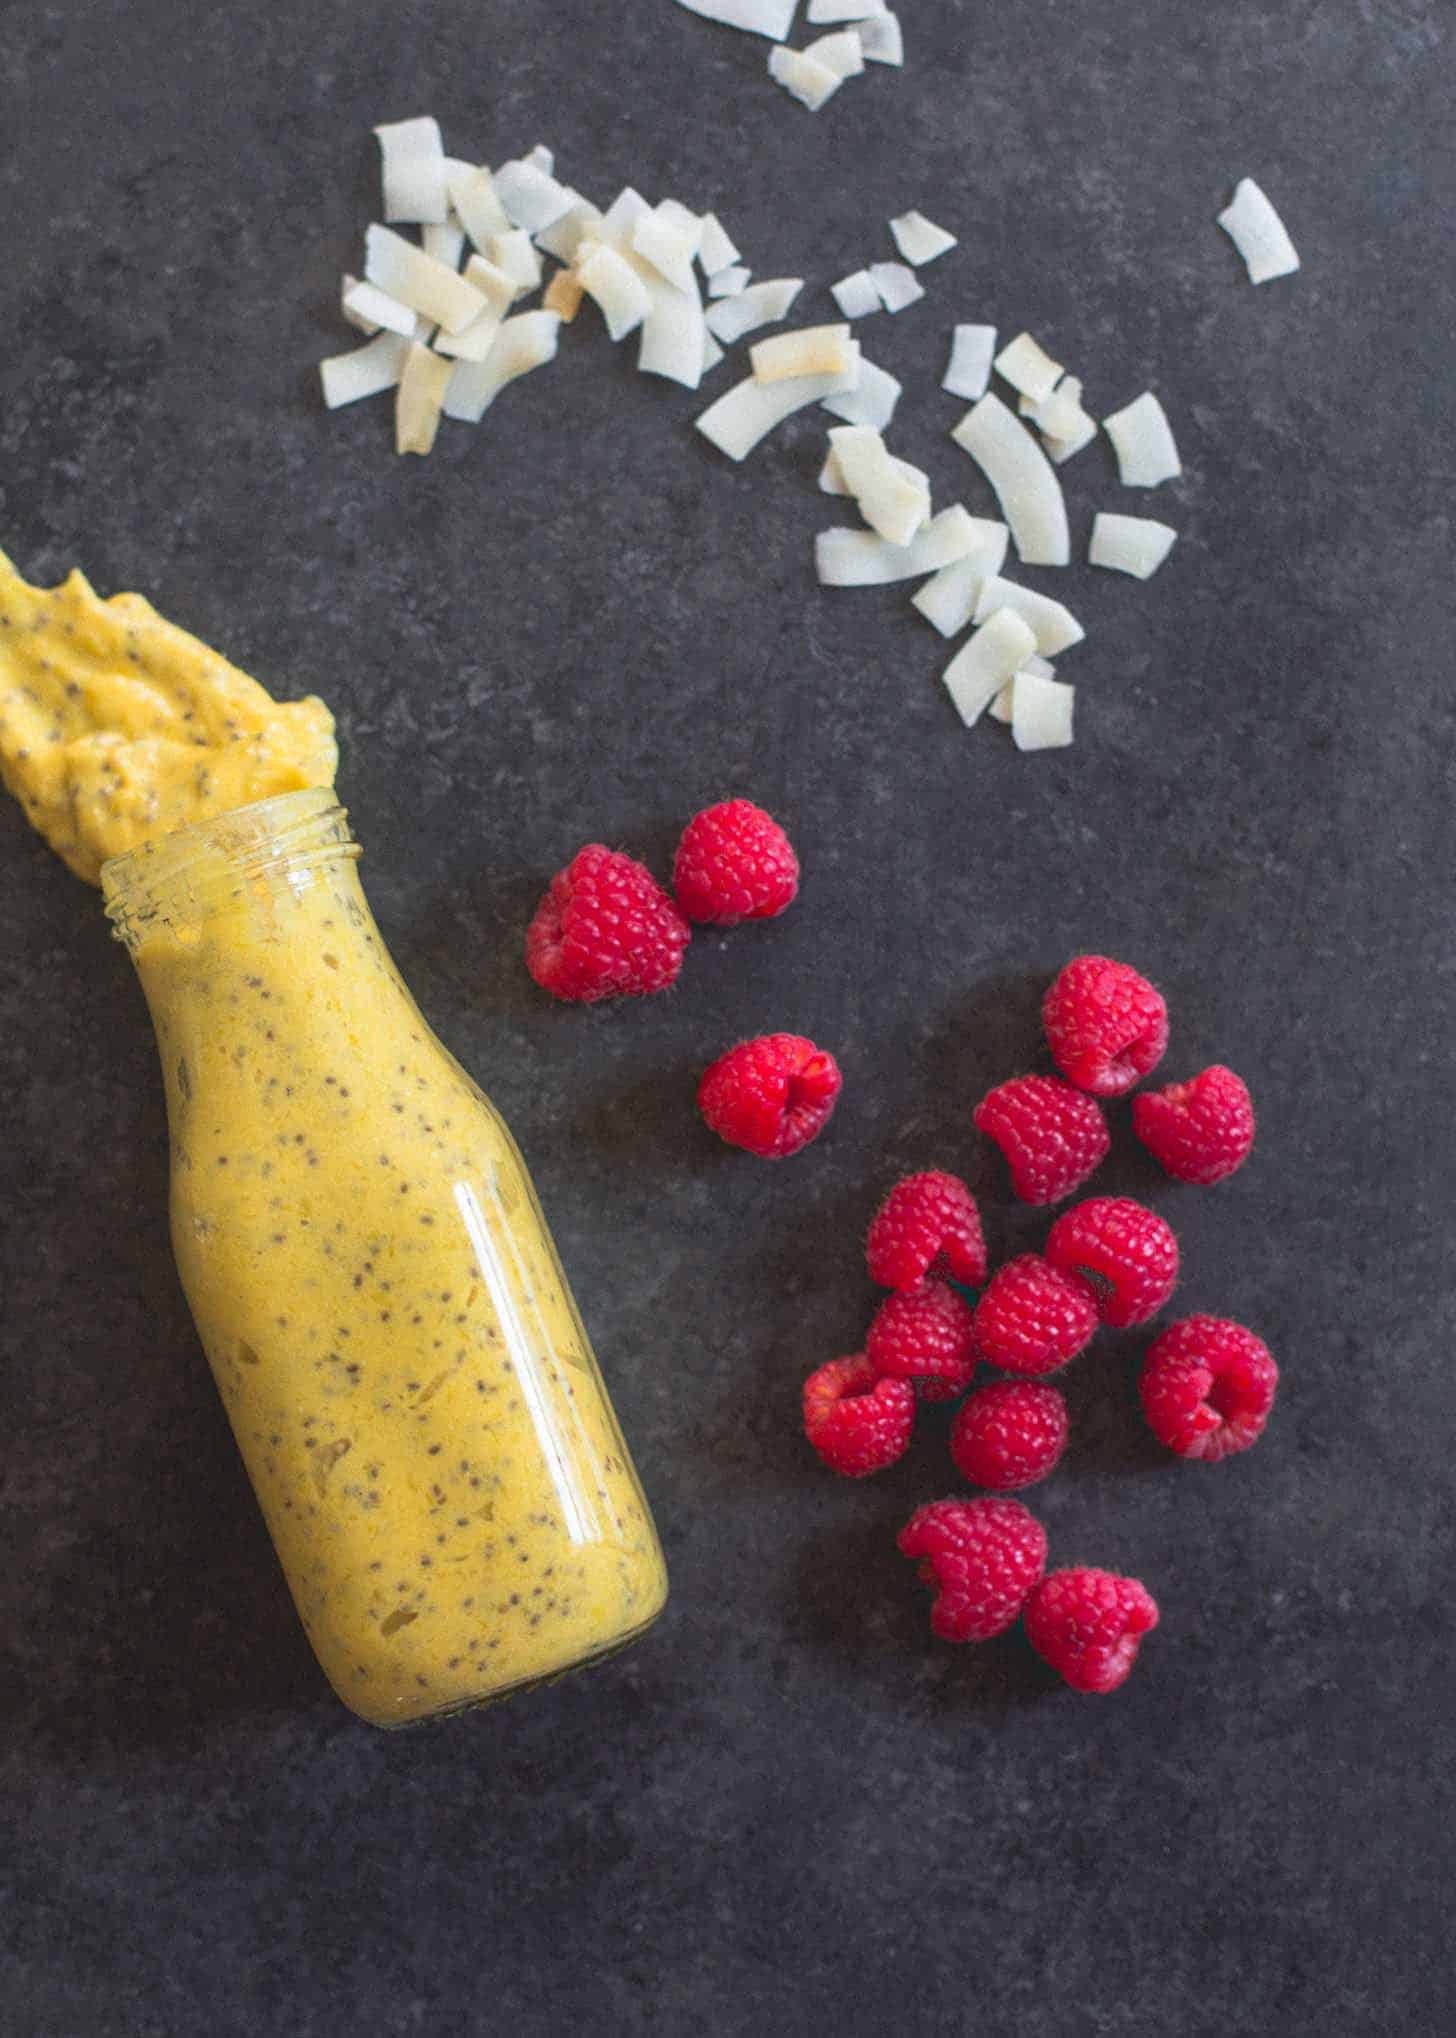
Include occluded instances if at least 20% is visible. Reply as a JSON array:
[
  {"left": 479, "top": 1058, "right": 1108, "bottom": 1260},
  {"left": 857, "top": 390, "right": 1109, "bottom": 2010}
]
[{"left": 526, "top": 842, "right": 691, "bottom": 1005}]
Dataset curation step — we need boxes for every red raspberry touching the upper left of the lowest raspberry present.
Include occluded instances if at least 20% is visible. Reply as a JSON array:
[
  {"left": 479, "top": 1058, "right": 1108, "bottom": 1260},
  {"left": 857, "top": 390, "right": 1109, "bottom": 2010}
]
[{"left": 897, "top": 1500, "right": 1046, "bottom": 1643}]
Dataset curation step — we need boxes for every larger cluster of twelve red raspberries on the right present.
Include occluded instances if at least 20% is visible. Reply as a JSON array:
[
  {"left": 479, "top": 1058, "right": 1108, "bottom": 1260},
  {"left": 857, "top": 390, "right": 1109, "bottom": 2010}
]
[{"left": 803, "top": 956, "right": 1279, "bottom": 1692}]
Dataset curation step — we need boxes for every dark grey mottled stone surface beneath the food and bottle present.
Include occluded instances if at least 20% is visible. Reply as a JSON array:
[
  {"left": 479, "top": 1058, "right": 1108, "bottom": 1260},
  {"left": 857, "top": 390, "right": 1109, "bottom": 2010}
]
[{"left": 0, "top": 0, "right": 1456, "bottom": 2038}]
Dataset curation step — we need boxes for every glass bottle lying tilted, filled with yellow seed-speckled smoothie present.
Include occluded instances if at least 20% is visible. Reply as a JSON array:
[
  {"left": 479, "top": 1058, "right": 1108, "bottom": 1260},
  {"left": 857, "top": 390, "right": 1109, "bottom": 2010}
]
[{"left": 102, "top": 791, "right": 667, "bottom": 1726}]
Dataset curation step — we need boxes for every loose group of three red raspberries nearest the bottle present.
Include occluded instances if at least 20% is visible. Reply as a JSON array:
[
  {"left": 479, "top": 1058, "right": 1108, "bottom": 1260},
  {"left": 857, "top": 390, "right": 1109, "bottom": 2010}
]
[{"left": 526, "top": 799, "right": 842, "bottom": 1160}]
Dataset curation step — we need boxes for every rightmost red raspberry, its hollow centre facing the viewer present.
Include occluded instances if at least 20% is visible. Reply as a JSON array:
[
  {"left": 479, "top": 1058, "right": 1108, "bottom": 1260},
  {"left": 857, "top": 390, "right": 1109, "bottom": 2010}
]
[{"left": 1138, "top": 1317, "right": 1279, "bottom": 1465}]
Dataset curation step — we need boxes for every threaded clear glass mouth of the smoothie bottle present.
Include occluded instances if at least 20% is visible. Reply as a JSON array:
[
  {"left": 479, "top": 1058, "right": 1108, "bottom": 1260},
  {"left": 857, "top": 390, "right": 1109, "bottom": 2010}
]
[{"left": 102, "top": 787, "right": 359, "bottom": 942}]
